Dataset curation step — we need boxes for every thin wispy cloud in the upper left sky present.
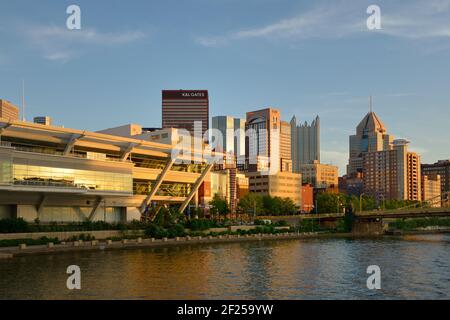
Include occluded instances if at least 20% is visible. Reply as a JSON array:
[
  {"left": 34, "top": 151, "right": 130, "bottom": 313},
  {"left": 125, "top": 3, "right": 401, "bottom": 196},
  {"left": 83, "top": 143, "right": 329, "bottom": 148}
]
[{"left": 19, "top": 26, "right": 145, "bottom": 62}]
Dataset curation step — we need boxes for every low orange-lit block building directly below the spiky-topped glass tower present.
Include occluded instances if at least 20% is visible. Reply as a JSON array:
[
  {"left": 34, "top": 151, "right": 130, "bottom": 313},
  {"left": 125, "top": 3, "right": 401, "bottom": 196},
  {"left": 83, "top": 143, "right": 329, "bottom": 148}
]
[{"left": 300, "top": 161, "right": 339, "bottom": 189}]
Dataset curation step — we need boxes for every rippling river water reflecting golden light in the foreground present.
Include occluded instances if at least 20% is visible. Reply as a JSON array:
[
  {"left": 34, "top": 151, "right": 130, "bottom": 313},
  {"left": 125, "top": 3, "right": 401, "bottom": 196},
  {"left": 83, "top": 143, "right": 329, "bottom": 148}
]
[{"left": 0, "top": 234, "right": 450, "bottom": 299}]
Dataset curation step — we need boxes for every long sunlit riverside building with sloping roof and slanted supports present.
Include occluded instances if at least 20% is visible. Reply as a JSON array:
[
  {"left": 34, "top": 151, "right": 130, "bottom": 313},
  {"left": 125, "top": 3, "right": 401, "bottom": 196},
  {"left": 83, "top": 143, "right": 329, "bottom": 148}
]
[{"left": 0, "top": 118, "right": 213, "bottom": 222}]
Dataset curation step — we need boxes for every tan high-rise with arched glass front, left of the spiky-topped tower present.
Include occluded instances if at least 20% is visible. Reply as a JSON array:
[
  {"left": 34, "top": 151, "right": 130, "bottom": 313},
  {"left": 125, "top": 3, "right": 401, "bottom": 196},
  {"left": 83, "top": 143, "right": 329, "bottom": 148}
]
[{"left": 245, "top": 108, "right": 281, "bottom": 173}]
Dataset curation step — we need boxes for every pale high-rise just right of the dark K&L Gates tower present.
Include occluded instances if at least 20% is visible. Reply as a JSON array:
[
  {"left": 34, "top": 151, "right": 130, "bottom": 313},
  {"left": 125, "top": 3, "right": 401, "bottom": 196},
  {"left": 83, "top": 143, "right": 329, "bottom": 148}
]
[{"left": 212, "top": 116, "right": 245, "bottom": 157}]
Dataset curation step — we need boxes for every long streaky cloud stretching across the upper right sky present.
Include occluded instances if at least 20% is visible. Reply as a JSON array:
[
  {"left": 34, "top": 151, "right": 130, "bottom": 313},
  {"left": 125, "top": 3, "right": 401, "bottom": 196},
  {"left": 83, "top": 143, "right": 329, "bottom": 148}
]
[{"left": 195, "top": 0, "right": 450, "bottom": 47}]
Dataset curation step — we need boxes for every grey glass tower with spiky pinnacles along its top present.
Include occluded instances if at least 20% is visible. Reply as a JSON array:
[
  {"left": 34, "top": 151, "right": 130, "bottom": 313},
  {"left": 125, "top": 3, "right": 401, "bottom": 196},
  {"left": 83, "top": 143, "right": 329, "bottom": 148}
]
[{"left": 290, "top": 116, "right": 320, "bottom": 172}]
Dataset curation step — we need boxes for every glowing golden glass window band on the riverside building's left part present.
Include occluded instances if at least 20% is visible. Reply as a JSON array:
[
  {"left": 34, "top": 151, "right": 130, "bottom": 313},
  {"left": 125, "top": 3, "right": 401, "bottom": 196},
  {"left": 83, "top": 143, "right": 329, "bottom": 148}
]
[{"left": 13, "top": 164, "right": 133, "bottom": 193}]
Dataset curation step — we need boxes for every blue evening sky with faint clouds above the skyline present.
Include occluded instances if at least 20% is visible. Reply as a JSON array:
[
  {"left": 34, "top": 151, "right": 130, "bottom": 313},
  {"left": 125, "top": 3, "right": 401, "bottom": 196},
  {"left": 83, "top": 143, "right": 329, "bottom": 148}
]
[{"left": 0, "top": 0, "right": 450, "bottom": 173}]
